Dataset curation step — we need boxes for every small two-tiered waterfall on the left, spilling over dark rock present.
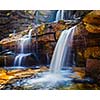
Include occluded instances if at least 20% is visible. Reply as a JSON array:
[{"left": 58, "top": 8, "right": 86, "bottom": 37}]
[{"left": 14, "top": 29, "right": 32, "bottom": 66}]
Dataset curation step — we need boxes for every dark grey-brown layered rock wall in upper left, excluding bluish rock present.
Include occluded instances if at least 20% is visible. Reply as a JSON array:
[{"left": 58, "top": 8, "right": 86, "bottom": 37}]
[{"left": 0, "top": 10, "right": 34, "bottom": 40}]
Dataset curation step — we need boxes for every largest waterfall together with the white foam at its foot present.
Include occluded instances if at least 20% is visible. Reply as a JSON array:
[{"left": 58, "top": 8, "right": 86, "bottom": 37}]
[{"left": 19, "top": 26, "right": 76, "bottom": 89}]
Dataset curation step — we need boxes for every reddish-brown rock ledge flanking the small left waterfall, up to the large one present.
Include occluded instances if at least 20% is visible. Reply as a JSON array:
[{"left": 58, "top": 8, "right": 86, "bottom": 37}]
[{"left": 0, "top": 20, "right": 72, "bottom": 65}]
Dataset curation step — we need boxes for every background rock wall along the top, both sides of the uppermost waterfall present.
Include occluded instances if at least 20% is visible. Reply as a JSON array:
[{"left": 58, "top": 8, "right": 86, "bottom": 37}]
[{"left": 0, "top": 10, "right": 89, "bottom": 40}]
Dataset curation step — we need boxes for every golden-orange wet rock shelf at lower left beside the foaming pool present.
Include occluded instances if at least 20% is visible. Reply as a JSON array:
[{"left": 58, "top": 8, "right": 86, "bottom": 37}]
[{"left": 0, "top": 66, "right": 48, "bottom": 89}]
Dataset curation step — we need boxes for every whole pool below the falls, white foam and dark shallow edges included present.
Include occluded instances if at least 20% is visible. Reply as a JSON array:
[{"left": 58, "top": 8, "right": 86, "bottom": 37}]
[{"left": 4, "top": 67, "right": 100, "bottom": 90}]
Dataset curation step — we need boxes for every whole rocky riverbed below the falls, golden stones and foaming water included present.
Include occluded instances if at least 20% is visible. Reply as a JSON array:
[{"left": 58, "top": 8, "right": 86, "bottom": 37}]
[{"left": 0, "top": 66, "right": 100, "bottom": 90}]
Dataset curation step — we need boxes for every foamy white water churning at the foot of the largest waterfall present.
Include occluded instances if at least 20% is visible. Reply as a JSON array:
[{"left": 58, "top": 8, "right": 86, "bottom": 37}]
[{"left": 23, "top": 70, "right": 73, "bottom": 90}]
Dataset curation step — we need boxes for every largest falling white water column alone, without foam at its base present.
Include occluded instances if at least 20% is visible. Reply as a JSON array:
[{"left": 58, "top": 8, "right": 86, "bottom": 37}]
[{"left": 50, "top": 26, "right": 76, "bottom": 73}]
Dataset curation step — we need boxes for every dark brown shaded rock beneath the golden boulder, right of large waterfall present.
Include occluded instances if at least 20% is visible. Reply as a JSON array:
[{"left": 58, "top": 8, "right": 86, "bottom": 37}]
[{"left": 73, "top": 21, "right": 100, "bottom": 67}]
